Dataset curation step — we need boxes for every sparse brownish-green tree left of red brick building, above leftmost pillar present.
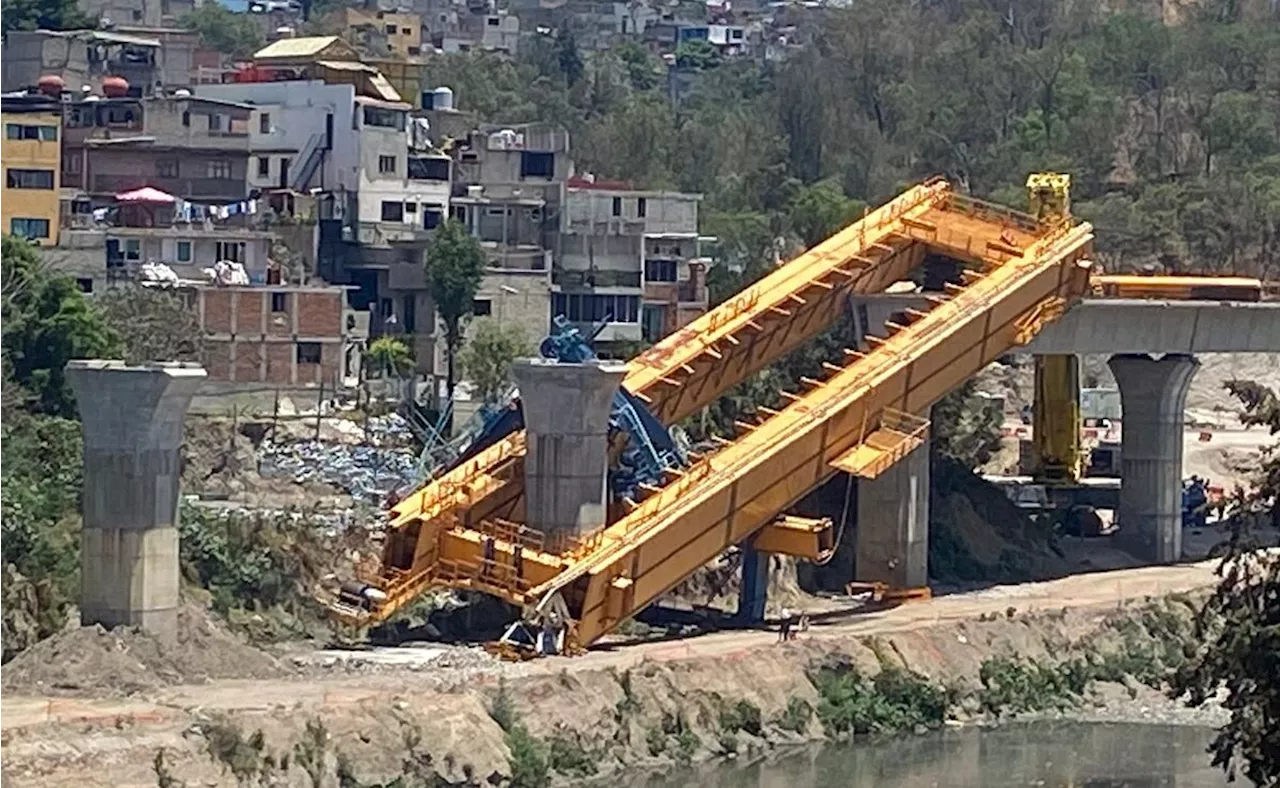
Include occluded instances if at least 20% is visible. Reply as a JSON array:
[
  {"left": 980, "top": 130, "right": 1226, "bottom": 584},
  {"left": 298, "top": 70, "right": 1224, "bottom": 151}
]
[{"left": 97, "top": 285, "right": 205, "bottom": 363}]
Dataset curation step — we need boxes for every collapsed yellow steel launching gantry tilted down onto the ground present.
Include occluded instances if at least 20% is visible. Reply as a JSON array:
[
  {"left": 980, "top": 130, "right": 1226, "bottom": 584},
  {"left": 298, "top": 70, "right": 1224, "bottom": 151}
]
[{"left": 332, "top": 180, "right": 1092, "bottom": 645}]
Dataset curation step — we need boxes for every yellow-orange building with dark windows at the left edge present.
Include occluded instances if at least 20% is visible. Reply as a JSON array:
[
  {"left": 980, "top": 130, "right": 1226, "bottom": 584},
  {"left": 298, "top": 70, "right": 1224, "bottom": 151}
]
[{"left": 0, "top": 96, "right": 63, "bottom": 246}]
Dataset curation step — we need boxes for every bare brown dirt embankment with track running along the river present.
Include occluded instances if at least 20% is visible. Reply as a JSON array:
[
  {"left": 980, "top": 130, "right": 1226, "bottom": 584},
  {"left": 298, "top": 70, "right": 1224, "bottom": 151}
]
[{"left": 0, "top": 565, "right": 1213, "bottom": 788}]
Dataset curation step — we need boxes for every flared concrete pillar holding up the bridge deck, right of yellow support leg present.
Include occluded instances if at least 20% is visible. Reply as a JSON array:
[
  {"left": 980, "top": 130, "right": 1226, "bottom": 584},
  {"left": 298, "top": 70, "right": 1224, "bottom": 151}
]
[{"left": 1107, "top": 354, "right": 1199, "bottom": 564}]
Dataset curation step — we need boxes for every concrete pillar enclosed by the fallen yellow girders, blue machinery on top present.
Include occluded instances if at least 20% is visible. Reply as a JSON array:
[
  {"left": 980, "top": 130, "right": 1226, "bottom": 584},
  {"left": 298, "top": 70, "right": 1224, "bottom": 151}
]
[{"left": 512, "top": 358, "right": 626, "bottom": 536}]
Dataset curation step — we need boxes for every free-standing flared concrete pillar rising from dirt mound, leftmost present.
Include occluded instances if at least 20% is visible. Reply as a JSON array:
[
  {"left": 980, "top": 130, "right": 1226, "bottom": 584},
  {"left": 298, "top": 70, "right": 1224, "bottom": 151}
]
[{"left": 67, "top": 361, "right": 205, "bottom": 634}]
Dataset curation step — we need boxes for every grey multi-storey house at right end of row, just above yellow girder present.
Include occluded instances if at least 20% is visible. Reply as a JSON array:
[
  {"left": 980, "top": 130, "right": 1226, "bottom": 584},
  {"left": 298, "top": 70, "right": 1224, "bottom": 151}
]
[{"left": 552, "top": 178, "right": 707, "bottom": 352}]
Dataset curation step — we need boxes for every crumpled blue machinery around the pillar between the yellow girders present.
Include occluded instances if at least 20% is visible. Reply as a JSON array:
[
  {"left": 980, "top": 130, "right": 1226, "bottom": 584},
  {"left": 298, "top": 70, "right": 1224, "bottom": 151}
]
[{"left": 424, "top": 315, "right": 685, "bottom": 500}]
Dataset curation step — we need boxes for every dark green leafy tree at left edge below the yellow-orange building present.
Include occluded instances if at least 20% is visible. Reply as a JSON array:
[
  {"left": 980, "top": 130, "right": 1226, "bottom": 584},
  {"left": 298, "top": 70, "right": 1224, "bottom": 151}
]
[{"left": 0, "top": 235, "right": 119, "bottom": 418}]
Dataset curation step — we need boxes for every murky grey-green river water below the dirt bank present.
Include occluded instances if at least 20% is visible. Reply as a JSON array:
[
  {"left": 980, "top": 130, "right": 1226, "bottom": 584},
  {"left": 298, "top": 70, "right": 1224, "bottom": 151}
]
[{"left": 635, "top": 723, "right": 1228, "bottom": 788}]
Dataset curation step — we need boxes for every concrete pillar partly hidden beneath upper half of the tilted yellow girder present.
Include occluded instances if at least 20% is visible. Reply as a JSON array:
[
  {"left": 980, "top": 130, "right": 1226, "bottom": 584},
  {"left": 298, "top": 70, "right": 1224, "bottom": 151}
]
[{"left": 854, "top": 441, "right": 929, "bottom": 588}]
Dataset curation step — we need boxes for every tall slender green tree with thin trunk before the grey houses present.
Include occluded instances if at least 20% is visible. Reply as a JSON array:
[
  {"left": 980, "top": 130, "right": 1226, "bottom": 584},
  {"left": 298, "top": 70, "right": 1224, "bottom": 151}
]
[{"left": 426, "top": 219, "right": 485, "bottom": 409}]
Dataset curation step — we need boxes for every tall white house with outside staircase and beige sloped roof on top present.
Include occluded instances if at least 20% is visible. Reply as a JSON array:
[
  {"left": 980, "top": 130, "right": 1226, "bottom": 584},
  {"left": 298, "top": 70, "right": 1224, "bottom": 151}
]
[{"left": 196, "top": 38, "right": 453, "bottom": 371}]
